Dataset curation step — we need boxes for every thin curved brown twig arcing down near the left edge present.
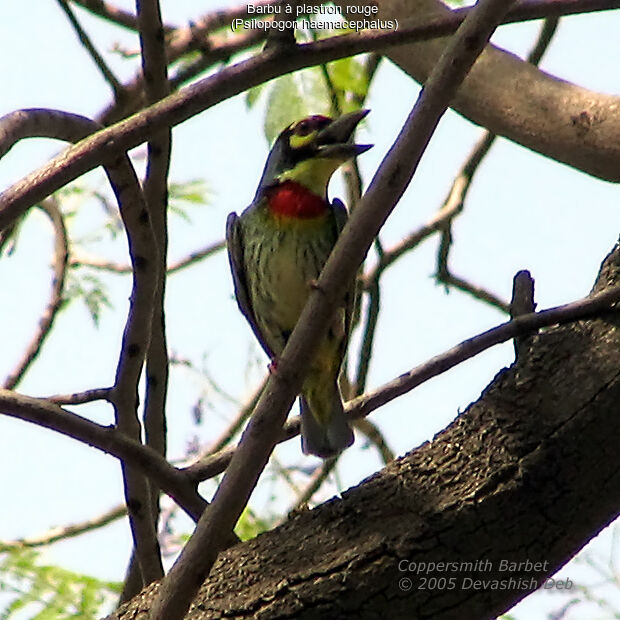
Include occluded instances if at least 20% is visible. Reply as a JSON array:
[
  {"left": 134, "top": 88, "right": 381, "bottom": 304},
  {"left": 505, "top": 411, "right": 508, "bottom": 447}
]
[{"left": 2, "top": 198, "right": 69, "bottom": 390}]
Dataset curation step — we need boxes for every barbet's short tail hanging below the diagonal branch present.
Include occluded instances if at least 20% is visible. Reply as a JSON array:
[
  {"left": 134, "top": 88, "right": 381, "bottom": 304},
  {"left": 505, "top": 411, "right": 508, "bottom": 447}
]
[{"left": 299, "top": 382, "right": 354, "bottom": 459}]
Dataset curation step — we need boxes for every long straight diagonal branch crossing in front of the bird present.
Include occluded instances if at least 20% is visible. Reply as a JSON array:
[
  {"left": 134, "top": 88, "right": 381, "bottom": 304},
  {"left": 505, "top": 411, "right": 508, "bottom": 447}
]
[{"left": 151, "top": 0, "right": 510, "bottom": 620}]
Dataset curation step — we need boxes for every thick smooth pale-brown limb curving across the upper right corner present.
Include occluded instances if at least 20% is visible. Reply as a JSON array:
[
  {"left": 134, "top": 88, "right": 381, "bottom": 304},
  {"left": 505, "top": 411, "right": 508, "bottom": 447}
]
[{"left": 336, "top": 0, "right": 620, "bottom": 183}]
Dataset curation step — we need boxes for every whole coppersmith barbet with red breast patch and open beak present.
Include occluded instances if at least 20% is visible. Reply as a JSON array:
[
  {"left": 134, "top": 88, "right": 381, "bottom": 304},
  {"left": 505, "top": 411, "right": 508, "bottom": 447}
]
[{"left": 226, "top": 110, "right": 372, "bottom": 458}]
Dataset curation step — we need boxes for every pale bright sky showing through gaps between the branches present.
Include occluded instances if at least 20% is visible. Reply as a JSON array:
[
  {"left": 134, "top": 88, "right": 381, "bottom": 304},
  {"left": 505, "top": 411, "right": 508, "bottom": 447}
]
[{"left": 0, "top": 0, "right": 620, "bottom": 619}]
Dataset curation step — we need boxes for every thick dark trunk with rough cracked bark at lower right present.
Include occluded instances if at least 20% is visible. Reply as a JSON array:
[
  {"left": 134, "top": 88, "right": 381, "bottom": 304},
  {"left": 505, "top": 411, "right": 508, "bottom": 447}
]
[{"left": 110, "top": 247, "right": 620, "bottom": 620}]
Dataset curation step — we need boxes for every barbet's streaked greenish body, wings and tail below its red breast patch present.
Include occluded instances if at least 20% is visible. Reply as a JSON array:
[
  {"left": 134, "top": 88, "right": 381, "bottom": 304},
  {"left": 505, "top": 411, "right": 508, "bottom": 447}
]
[{"left": 227, "top": 199, "right": 353, "bottom": 457}]
